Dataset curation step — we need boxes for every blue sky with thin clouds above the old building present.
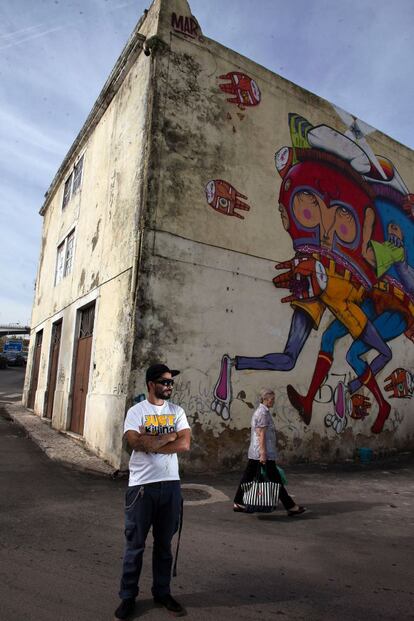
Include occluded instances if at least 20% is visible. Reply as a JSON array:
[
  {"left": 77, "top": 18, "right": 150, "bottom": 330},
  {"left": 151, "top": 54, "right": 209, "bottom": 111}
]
[{"left": 0, "top": 0, "right": 414, "bottom": 323}]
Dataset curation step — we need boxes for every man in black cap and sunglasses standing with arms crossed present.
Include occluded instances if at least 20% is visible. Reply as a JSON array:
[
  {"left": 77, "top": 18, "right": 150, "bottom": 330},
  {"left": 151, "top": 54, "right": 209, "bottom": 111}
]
[{"left": 115, "top": 364, "right": 190, "bottom": 619}]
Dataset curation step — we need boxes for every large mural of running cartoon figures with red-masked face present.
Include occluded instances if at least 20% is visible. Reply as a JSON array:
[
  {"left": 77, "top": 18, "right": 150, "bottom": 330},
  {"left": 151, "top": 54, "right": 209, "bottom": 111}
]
[{"left": 212, "top": 113, "right": 414, "bottom": 434}]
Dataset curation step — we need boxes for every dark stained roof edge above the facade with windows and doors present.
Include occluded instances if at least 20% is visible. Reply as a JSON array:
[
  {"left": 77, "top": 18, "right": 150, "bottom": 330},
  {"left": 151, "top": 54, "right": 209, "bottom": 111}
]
[{"left": 39, "top": 11, "right": 148, "bottom": 216}]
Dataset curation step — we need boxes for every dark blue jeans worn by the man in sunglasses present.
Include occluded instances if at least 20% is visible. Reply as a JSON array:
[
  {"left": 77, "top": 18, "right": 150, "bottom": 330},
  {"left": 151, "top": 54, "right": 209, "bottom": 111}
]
[{"left": 119, "top": 481, "right": 181, "bottom": 599}]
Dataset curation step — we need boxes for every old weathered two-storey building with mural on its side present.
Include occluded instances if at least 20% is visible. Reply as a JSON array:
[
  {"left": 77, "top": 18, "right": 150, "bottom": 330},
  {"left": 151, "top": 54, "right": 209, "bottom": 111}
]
[{"left": 24, "top": 0, "right": 414, "bottom": 471}]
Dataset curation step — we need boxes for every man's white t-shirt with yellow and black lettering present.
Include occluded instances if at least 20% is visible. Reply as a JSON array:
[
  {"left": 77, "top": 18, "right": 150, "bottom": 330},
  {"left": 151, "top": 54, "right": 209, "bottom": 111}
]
[{"left": 124, "top": 399, "right": 190, "bottom": 487}]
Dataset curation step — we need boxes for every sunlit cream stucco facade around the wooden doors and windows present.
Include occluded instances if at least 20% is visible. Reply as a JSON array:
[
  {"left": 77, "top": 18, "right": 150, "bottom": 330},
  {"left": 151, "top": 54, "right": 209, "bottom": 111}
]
[{"left": 25, "top": 27, "right": 154, "bottom": 466}]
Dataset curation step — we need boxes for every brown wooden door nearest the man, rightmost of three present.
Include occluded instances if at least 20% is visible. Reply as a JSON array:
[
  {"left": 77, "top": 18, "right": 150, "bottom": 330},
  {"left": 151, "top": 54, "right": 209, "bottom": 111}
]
[{"left": 70, "top": 304, "right": 95, "bottom": 435}]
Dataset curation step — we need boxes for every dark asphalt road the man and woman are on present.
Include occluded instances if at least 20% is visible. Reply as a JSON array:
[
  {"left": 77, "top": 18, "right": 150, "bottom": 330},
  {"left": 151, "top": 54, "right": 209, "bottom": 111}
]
[{"left": 0, "top": 398, "right": 414, "bottom": 621}]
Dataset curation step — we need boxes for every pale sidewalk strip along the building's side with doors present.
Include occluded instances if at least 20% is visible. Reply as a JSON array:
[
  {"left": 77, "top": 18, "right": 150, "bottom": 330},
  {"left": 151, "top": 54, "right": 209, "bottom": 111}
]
[{"left": 1, "top": 403, "right": 118, "bottom": 478}]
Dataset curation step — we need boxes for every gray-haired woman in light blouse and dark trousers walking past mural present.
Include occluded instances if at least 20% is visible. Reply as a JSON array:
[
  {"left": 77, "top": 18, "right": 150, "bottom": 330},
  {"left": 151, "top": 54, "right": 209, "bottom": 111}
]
[{"left": 233, "top": 388, "right": 306, "bottom": 517}]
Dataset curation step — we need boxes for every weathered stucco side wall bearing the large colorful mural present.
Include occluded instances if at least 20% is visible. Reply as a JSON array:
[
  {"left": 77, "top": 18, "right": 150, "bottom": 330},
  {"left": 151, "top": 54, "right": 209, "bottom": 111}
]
[{"left": 131, "top": 1, "right": 414, "bottom": 469}]
